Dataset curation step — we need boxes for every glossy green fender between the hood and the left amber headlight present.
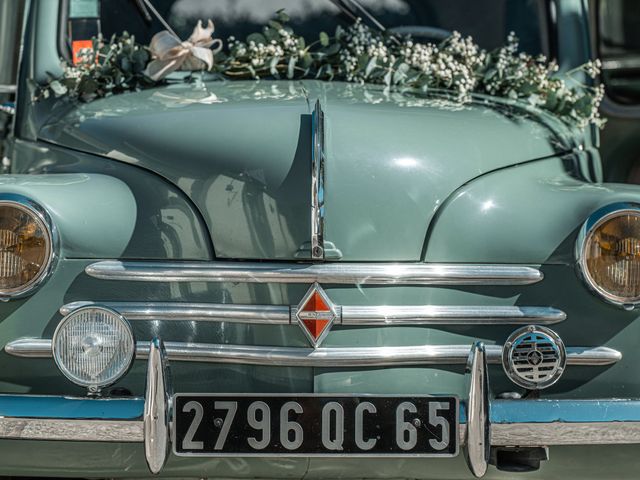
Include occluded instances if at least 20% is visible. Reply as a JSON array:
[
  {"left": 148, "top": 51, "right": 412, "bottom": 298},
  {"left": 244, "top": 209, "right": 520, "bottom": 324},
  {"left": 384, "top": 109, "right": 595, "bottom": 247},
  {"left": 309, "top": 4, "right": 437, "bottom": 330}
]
[{"left": 10, "top": 140, "right": 212, "bottom": 260}]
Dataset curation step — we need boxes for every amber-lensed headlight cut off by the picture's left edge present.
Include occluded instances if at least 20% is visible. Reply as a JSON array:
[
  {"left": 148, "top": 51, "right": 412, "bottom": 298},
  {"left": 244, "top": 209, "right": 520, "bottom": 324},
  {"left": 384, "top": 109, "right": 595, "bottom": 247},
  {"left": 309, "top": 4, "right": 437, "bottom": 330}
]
[{"left": 0, "top": 194, "right": 54, "bottom": 298}]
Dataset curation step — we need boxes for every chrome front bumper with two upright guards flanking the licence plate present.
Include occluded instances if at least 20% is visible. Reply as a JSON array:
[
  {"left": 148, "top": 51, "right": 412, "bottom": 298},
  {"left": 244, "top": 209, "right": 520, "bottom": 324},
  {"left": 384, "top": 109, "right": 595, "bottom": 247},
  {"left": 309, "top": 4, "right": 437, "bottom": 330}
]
[{"left": 0, "top": 338, "right": 640, "bottom": 477}]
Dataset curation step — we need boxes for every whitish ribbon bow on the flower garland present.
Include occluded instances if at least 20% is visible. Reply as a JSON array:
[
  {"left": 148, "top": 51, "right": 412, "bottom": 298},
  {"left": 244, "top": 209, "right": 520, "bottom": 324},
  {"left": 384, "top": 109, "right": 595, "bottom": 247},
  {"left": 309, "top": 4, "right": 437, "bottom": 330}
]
[{"left": 145, "top": 20, "right": 222, "bottom": 82}]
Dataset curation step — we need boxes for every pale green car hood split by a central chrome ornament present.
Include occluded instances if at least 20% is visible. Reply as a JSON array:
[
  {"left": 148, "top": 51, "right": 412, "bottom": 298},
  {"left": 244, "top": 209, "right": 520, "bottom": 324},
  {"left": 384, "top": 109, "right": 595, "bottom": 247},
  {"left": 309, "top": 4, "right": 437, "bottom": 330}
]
[{"left": 39, "top": 81, "right": 575, "bottom": 261}]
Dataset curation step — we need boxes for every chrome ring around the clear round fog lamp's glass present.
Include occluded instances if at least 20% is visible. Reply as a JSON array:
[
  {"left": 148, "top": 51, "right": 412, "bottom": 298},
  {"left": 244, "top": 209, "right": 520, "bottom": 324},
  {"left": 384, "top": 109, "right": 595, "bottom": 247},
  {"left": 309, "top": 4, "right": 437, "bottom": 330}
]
[{"left": 51, "top": 305, "right": 136, "bottom": 392}]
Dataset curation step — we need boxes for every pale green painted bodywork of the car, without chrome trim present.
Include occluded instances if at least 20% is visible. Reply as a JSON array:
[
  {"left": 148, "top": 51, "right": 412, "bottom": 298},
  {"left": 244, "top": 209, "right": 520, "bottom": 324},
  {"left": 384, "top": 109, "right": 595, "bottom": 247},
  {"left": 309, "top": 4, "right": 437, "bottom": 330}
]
[{"left": 0, "top": 0, "right": 640, "bottom": 479}]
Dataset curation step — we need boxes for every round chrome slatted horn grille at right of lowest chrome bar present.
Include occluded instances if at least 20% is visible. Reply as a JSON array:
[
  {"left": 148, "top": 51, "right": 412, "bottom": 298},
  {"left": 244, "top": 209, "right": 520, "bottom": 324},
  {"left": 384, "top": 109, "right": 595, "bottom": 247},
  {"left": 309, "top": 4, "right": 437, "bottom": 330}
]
[{"left": 502, "top": 325, "right": 567, "bottom": 390}]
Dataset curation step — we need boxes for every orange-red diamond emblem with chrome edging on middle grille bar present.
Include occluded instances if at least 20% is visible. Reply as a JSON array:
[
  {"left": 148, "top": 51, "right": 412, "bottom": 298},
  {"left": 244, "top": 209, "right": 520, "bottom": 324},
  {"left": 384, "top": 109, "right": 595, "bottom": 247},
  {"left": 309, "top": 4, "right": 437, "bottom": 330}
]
[{"left": 295, "top": 283, "right": 338, "bottom": 348}]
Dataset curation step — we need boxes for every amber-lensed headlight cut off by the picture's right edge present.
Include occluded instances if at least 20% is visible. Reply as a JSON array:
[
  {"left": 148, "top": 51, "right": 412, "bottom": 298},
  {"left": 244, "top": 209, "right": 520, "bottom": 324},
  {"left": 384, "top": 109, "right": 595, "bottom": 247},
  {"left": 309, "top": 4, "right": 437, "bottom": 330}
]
[{"left": 576, "top": 203, "right": 640, "bottom": 308}]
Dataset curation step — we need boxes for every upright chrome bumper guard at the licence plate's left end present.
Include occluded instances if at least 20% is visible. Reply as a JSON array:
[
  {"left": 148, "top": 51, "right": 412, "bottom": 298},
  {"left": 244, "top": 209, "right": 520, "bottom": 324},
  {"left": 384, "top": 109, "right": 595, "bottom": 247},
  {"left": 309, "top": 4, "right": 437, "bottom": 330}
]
[{"left": 142, "top": 338, "right": 172, "bottom": 474}]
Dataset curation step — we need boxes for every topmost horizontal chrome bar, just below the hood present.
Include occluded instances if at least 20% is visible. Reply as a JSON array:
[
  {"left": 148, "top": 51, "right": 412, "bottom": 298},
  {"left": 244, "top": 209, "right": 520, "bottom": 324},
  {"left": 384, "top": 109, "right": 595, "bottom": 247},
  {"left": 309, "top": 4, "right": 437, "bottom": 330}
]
[{"left": 85, "top": 260, "right": 543, "bottom": 285}]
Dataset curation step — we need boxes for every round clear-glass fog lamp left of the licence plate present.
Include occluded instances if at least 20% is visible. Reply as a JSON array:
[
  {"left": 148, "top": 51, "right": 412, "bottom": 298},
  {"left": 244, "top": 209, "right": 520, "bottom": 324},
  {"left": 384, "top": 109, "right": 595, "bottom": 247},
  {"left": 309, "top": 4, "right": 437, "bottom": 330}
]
[{"left": 52, "top": 307, "right": 136, "bottom": 391}]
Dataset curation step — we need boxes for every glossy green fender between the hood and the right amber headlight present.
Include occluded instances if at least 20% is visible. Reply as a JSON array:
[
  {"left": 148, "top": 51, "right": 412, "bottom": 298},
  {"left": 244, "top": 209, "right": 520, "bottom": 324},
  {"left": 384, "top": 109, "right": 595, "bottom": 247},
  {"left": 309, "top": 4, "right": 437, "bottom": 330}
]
[{"left": 425, "top": 158, "right": 640, "bottom": 265}]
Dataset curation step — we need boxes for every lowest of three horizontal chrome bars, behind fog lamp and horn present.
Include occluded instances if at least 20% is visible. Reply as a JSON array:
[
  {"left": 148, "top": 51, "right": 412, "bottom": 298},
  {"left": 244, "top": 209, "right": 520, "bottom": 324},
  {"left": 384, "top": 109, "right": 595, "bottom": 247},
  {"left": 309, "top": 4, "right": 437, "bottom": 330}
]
[{"left": 4, "top": 338, "right": 622, "bottom": 367}]
